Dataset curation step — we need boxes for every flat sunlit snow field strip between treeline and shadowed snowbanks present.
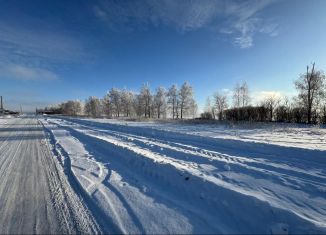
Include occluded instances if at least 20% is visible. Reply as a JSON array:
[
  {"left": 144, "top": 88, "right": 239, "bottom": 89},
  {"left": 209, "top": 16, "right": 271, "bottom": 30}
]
[{"left": 79, "top": 119, "right": 326, "bottom": 150}]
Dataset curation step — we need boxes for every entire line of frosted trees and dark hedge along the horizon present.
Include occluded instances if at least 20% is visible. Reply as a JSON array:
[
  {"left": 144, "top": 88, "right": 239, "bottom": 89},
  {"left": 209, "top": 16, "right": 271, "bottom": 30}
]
[{"left": 37, "top": 63, "right": 326, "bottom": 124}]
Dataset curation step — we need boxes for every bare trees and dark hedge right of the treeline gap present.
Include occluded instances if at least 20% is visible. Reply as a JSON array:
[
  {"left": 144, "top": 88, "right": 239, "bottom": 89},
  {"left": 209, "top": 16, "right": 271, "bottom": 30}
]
[{"left": 201, "top": 63, "right": 326, "bottom": 124}]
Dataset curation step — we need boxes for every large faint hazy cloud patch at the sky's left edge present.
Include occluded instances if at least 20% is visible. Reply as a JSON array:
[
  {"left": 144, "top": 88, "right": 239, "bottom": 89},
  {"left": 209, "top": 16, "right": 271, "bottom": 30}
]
[{"left": 0, "top": 21, "right": 84, "bottom": 81}]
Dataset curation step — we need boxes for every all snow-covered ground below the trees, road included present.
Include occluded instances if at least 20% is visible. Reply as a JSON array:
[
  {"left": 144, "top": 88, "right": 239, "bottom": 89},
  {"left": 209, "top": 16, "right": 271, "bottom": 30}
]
[{"left": 0, "top": 117, "right": 326, "bottom": 234}]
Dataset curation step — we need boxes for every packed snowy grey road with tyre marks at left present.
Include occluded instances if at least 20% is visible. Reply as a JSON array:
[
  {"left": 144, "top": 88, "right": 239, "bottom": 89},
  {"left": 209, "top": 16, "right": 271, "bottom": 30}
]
[{"left": 0, "top": 117, "right": 99, "bottom": 234}]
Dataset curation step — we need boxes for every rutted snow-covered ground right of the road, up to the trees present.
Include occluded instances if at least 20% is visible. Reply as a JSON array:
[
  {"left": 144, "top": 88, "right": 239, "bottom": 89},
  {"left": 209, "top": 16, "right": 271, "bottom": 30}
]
[{"left": 40, "top": 117, "right": 326, "bottom": 234}]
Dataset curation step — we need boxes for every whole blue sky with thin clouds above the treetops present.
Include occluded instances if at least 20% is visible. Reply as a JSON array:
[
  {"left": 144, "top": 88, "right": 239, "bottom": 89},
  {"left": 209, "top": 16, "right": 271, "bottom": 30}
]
[{"left": 0, "top": 0, "right": 326, "bottom": 110}]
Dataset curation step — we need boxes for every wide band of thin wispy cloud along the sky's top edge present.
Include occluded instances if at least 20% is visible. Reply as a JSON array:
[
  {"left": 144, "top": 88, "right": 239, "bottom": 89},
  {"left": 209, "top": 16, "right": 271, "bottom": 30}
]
[{"left": 94, "top": 0, "right": 277, "bottom": 48}]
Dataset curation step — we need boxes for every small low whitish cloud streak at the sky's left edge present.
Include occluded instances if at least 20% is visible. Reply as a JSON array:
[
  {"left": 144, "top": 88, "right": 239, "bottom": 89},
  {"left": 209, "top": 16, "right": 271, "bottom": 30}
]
[{"left": 0, "top": 64, "right": 59, "bottom": 81}]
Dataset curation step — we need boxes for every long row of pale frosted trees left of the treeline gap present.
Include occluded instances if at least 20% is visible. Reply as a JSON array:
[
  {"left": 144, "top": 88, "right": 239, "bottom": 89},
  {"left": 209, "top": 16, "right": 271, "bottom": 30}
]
[{"left": 40, "top": 82, "right": 197, "bottom": 119}]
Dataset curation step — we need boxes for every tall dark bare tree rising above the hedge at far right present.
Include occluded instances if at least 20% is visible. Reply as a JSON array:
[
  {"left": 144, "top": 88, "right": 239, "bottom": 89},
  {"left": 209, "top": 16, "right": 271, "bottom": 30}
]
[{"left": 295, "top": 63, "right": 325, "bottom": 124}]
